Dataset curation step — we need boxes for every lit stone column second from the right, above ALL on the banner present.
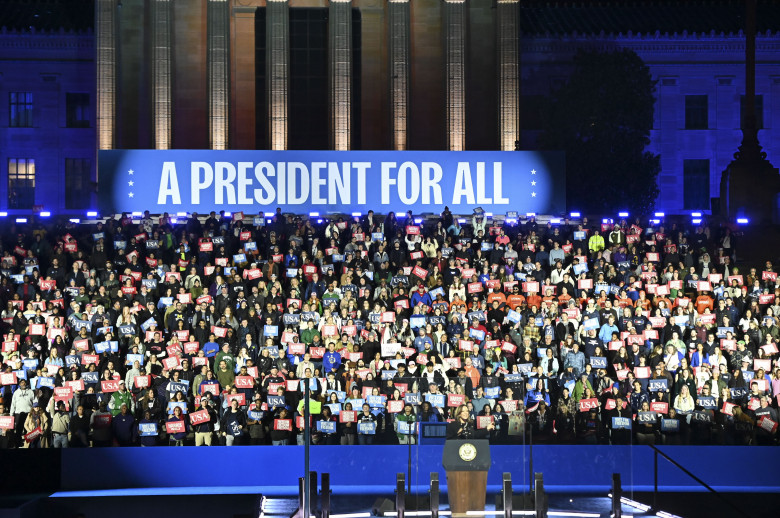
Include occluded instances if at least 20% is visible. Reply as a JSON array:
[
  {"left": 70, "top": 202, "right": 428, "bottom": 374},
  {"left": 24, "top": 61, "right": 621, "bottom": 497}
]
[{"left": 444, "top": 0, "right": 466, "bottom": 151}]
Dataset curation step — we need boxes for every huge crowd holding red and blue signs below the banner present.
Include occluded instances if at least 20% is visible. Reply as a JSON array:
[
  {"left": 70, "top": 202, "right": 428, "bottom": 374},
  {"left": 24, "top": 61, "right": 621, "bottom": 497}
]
[{"left": 0, "top": 209, "right": 780, "bottom": 448}]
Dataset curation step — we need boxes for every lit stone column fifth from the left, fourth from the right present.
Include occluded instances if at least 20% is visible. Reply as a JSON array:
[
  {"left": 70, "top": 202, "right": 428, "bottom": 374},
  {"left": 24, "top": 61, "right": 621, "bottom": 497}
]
[{"left": 328, "top": 0, "right": 352, "bottom": 151}]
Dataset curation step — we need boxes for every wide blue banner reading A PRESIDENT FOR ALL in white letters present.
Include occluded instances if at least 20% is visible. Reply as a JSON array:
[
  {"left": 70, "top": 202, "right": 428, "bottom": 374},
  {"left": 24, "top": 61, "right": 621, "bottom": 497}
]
[{"left": 98, "top": 150, "right": 566, "bottom": 214}]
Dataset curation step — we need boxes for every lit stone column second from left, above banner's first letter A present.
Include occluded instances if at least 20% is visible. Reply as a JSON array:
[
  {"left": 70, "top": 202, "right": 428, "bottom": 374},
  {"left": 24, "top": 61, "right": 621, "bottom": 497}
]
[{"left": 150, "top": 0, "right": 173, "bottom": 149}]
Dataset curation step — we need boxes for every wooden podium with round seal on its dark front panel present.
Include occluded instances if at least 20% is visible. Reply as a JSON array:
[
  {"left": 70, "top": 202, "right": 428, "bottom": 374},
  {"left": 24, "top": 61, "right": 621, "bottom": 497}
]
[{"left": 442, "top": 439, "right": 490, "bottom": 515}]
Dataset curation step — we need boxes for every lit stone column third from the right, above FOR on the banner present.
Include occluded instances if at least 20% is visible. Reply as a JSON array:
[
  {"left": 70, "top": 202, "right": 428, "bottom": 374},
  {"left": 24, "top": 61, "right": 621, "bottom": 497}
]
[{"left": 388, "top": 0, "right": 411, "bottom": 151}]
